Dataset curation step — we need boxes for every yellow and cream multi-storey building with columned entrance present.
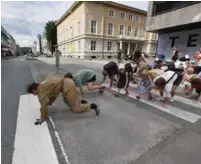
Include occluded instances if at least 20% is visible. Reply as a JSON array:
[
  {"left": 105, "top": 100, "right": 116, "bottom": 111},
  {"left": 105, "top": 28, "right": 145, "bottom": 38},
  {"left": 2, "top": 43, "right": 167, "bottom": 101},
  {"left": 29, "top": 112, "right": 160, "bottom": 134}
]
[{"left": 56, "top": 1, "right": 147, "bottom": 58}]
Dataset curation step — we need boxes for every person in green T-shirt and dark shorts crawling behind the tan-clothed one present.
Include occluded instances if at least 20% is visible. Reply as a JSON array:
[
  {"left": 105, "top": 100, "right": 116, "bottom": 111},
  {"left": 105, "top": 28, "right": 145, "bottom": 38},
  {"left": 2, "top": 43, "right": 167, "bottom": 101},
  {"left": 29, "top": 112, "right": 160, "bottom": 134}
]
[{"left": 64, "top": 69, "right": 105, "bottom": 99}]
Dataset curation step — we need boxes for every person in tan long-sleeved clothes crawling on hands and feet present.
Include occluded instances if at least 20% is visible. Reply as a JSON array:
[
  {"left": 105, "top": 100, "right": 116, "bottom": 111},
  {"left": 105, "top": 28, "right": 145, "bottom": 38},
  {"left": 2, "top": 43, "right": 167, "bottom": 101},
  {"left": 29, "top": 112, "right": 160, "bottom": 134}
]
[{"left": 27, "top": 77, "right": 100, "bottom": 125}]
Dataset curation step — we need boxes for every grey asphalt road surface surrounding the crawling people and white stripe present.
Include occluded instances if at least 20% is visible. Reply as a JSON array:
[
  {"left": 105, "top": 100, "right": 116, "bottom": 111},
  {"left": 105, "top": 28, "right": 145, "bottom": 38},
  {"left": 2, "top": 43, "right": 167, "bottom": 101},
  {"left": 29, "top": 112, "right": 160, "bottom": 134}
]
[{"left": 1, "top": 56, "right": 201, "bottom": 164}]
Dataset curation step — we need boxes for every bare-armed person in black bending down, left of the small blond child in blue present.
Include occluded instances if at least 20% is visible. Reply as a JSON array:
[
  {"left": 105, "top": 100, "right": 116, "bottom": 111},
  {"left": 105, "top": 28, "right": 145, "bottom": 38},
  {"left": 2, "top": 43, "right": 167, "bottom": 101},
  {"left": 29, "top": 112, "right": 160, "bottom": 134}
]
[{"left": 114, "top": 63, "right": 133, "bottom": 97}]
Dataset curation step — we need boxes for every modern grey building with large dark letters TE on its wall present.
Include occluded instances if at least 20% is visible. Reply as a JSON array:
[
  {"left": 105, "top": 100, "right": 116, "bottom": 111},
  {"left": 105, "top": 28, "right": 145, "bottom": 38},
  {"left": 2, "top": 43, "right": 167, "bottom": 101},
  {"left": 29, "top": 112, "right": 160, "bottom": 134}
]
[{"left": 146, "top": 1, "right": 201, "bottom": 58}]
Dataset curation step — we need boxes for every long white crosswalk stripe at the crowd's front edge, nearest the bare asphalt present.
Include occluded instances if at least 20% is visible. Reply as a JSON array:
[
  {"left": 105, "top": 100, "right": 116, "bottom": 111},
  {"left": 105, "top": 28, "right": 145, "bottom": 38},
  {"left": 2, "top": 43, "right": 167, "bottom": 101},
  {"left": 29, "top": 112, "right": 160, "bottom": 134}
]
[{"left": 105, "top": 84, "right": 201, "bottom": 123}]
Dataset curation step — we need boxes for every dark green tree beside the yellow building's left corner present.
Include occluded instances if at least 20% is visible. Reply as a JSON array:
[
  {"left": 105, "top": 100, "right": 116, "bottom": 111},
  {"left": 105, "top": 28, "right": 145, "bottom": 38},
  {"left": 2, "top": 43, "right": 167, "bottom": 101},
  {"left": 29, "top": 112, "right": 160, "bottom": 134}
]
[{"left": 44, "top": 21, "right": 57, "bottom": 53}]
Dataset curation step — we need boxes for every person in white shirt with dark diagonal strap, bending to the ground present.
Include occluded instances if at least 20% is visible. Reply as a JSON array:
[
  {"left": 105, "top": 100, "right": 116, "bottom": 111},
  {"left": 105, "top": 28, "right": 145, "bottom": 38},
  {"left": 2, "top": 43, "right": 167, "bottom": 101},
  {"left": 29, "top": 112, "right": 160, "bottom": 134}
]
[{"left": 154, "top": 71, "right": 183, "bottom": 106}]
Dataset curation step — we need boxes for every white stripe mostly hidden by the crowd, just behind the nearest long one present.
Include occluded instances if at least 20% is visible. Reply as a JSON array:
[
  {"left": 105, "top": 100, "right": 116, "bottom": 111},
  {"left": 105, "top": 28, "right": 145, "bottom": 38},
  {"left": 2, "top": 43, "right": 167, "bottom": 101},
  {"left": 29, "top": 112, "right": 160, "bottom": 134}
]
[{"left": 129, "top": 83, "right": 199, "bottom": 108}]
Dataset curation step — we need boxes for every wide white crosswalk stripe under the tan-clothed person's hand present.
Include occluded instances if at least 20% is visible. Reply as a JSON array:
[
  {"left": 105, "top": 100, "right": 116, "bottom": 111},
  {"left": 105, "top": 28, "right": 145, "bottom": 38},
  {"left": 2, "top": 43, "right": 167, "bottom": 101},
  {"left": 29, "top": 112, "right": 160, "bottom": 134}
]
[{"left": 12, "top": 95, "right": 59, "bottom": 164}]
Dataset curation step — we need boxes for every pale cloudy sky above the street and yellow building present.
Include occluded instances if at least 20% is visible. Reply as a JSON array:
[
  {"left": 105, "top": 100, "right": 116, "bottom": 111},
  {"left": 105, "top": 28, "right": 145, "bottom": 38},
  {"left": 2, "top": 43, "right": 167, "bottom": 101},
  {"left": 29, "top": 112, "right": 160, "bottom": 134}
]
[{"left": 1, "top": 1, "right": 148, "bottom": 47}]
